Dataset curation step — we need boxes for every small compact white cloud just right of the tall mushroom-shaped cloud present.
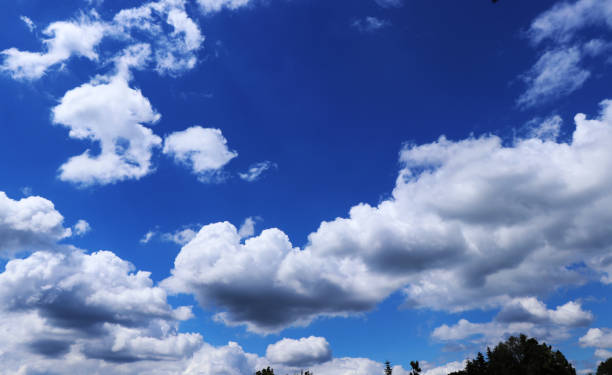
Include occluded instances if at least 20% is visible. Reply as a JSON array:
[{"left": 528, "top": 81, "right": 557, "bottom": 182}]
[{"left": 164, "top": 126, "right": 238, "bottom": 182}]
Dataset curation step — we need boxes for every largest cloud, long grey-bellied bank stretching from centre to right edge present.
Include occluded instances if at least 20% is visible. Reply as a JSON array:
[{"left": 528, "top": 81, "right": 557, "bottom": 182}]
[{"left": 163, "top": 101, "right": 612, "bottom": 333}]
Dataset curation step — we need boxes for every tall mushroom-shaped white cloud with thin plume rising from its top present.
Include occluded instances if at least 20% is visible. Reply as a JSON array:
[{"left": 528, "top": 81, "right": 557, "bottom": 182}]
[{"left": 53, "top": 45, "right": 161, "bottom": 186}]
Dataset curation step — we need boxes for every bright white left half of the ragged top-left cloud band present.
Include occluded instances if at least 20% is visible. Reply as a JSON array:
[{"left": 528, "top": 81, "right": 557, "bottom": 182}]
[{"left": 0, "top": 16, "right": 108, "bottom": 79}]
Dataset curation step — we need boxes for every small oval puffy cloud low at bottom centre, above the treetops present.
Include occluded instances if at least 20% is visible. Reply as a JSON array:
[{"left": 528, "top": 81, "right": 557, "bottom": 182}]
[{"left": 266, "top": 336, "right": 332, "bottom": 368}]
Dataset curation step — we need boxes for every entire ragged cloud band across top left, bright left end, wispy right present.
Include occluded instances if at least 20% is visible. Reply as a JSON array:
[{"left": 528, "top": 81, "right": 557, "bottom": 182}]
[{"left": 0, "top": 0, "right": 204, "bottom": 80}]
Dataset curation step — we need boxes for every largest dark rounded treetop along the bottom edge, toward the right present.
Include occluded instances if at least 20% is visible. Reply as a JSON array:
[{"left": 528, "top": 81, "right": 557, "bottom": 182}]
[{"left": 449, "top": 335, "right": 576, "bottom": 375}]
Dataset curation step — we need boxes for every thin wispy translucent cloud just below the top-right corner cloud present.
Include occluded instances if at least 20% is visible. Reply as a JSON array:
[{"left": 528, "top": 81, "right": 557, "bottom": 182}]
[{"left": 517, "top": 47, "right": 591, "bottom": 107}]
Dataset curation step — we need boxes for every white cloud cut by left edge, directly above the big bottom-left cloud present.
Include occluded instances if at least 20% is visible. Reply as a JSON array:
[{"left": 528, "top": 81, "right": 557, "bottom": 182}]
[{"left": 0, "top": 191, "right": 72, "bottom": 255}]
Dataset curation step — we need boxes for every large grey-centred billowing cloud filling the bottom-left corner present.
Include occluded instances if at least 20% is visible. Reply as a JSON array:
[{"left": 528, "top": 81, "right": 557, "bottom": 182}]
[{"left": 0, "top": 250, "right": 202, "bottom": 373}]
